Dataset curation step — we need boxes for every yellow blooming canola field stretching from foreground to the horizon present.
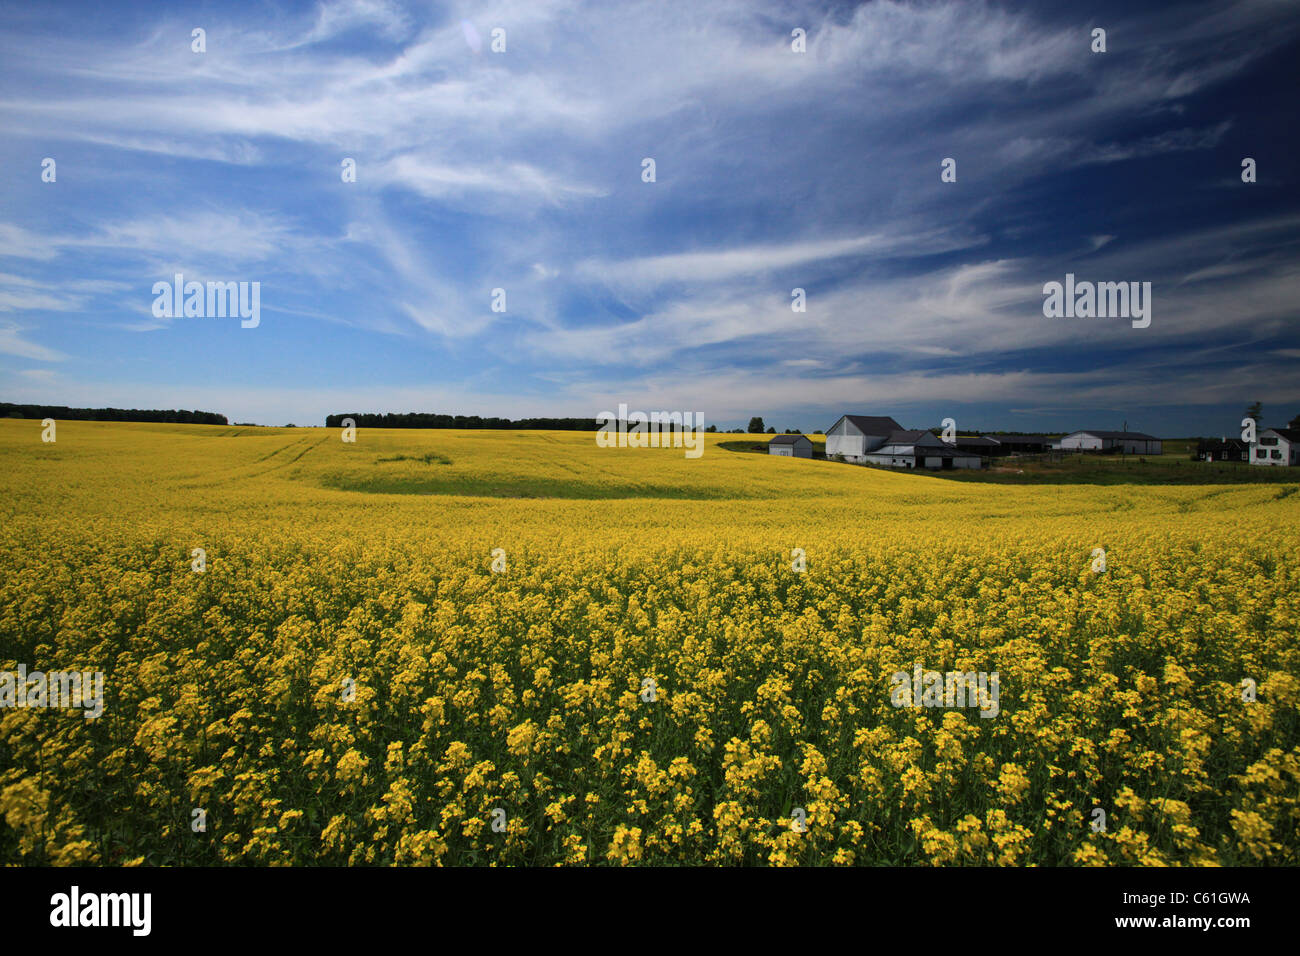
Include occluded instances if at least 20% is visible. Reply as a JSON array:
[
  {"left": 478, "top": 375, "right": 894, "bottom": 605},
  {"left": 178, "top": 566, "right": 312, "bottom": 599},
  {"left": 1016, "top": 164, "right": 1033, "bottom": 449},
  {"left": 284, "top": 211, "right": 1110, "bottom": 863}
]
[{"left": 0, "top": 420, "right": 1300, "bottom": 865}]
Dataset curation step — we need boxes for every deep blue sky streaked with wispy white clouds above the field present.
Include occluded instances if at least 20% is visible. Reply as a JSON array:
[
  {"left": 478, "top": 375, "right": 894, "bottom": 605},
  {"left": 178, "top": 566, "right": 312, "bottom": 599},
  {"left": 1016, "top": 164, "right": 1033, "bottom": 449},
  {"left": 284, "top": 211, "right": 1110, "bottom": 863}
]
[{"left": 0, "top": 0, "right": 1300, "bottom": 436}]
